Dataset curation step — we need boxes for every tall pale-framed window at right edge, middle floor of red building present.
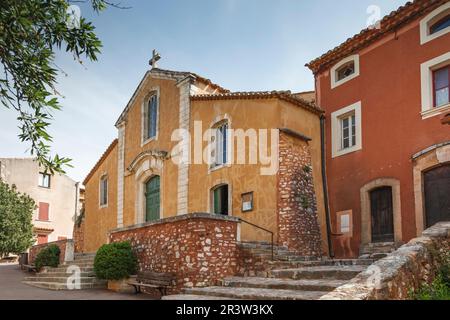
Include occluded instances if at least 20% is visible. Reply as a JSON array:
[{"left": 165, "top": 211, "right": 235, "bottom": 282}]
[{"left": 420, "top": 52, "right": 450, "bottom": 119}]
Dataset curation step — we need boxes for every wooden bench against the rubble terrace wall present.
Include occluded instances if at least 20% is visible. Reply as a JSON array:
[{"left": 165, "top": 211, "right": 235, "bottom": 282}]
[{"left": 128, "top": 271, "right": 176, "bottom": 296}]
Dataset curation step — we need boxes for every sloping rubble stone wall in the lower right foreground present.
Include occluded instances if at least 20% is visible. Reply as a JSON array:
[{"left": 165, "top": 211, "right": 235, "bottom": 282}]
[{"left": 321, "top": 222, "right": 450, "bottom": 300}]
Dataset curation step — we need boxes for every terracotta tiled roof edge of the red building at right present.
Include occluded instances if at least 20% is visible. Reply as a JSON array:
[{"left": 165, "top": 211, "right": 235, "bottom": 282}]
[{"left": 306, "top": 0, "right": 449, "bottom": 74}]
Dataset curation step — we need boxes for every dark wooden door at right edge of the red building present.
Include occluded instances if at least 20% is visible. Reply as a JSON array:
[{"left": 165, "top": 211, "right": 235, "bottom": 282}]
[{"left": 424, "top": 164, "right": 450, "bottom": 228}]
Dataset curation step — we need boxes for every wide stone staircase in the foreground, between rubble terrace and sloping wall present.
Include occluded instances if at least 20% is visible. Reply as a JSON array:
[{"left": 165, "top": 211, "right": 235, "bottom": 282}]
[{"left": 163, "top": 244, "right": 374, "bottom": 300}]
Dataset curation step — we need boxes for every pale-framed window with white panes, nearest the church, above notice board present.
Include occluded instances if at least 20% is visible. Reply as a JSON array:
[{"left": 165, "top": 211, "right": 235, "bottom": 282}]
[{"left": 331, "top": 102, "right": 362, "bottom": 158}]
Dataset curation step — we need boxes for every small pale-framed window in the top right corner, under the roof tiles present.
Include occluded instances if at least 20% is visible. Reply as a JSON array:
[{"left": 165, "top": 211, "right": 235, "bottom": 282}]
[{"left": 420, "top": 2, "right": 450, "bottom": 44}]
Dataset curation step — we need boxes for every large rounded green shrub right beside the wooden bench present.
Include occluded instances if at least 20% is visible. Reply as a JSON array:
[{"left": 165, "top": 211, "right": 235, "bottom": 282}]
[{"left": 94, "top": 242, "right": 137, "bottom": 280}]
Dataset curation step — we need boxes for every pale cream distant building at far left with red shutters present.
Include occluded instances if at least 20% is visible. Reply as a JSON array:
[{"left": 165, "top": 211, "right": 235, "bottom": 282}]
[{"left": 0, "top": 158, "right": 81, "bottom": 244}]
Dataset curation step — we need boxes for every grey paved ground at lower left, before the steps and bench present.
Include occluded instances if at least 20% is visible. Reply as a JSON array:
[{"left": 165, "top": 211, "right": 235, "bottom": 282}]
[{"left": 0, "top": 264, "right": 153, "bottom": 300}]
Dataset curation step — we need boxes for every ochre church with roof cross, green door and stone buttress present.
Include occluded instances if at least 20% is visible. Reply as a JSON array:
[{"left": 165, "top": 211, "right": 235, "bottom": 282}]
[{"left": 83, "top": 52, "right": 328, "bottom": 257}]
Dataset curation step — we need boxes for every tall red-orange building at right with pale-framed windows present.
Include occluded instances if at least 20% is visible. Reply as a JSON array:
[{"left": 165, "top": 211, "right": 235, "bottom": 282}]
[{"left": 307, "top": 0, "right": 450, "bottom": 257}]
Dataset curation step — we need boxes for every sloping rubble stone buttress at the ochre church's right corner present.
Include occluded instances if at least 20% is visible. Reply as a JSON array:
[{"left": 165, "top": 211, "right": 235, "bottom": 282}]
[{"left": 277, "top": 132, "right": 322, "bottom": 257}]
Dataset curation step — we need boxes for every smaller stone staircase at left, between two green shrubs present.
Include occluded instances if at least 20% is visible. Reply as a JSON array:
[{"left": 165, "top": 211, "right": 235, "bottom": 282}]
[{"left": 23, "top": 253, "right": 107, "bottom": 290}]
